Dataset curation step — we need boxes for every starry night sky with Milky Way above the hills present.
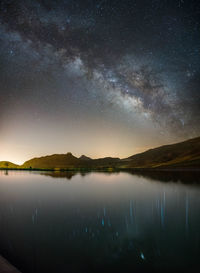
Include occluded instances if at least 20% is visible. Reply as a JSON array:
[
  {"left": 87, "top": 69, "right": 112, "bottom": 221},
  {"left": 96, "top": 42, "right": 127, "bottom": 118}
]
[{"left": 0, "top": 0, "right": 200, "bottom": 163}]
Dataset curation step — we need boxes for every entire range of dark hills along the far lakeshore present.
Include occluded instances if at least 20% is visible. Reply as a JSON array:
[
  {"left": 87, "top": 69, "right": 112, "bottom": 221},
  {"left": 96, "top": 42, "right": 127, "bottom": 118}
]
[{"left": 0, "top": 137, "right": 200, "bottom": 169}]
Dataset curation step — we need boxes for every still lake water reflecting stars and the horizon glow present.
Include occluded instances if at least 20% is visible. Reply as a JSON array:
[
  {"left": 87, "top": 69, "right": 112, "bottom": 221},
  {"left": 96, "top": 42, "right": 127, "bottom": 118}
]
[{"left": 0, "top": 171, "right": 200, "bottom": 273}]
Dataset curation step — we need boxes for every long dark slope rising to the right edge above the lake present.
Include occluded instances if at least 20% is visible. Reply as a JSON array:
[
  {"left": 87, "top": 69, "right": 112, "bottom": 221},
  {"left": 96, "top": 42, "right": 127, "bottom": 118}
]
[{"left": 122, "top": 137, "right": 200, "bottom": 168}]
